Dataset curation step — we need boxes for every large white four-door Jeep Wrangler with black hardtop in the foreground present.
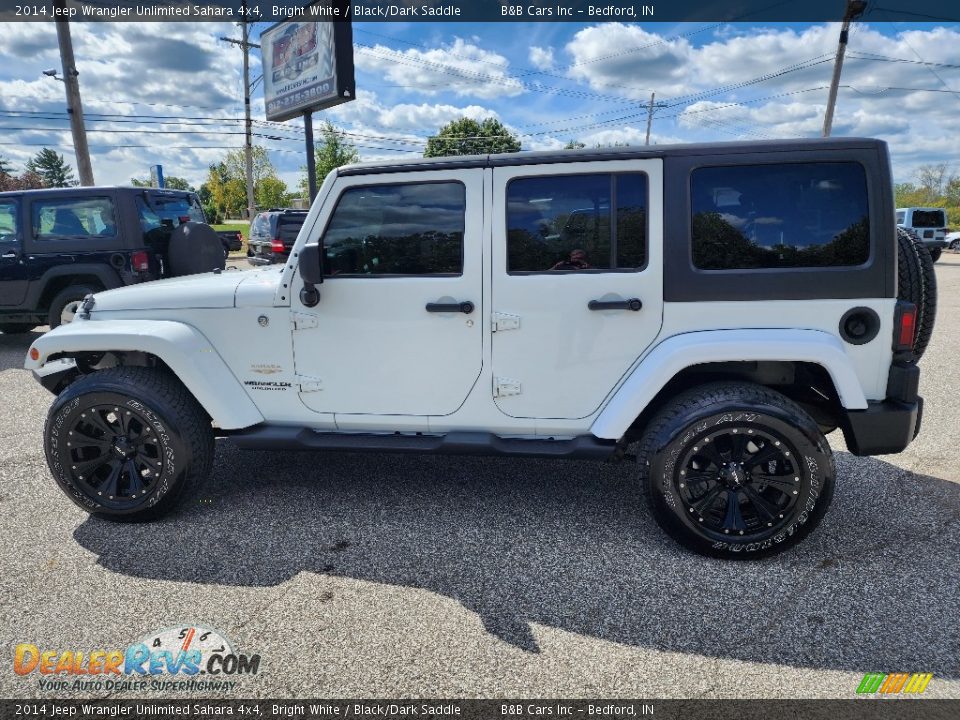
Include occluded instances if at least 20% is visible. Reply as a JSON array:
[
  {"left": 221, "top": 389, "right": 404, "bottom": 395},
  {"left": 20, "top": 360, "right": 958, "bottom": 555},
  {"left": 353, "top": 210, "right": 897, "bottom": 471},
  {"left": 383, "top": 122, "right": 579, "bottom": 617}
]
[{"left": 26, "top": 139, "right": 936, "bottom": 557}]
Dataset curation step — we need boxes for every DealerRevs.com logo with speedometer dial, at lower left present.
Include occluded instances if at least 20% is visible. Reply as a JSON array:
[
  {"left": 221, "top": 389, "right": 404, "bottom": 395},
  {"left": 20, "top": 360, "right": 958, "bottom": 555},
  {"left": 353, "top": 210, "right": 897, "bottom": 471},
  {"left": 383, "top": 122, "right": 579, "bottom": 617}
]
[{"left": 13, "top": 623, "right": 260, "bottom": 691}]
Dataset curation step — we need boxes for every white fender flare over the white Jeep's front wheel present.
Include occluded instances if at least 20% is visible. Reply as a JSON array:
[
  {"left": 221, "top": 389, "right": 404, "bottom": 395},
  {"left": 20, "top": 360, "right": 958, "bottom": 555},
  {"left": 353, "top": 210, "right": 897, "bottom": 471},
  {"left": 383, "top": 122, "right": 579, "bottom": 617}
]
[{"left": 24, "top": 319, "right": 263, "bottom": 430}]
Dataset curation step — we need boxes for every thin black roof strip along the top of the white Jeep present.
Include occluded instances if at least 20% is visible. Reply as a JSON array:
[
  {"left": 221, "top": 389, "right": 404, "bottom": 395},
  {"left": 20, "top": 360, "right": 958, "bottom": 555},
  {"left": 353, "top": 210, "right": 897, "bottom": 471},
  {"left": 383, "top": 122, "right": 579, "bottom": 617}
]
[{"left": 337, "top": 137, "right": 886, "bottom": 175}]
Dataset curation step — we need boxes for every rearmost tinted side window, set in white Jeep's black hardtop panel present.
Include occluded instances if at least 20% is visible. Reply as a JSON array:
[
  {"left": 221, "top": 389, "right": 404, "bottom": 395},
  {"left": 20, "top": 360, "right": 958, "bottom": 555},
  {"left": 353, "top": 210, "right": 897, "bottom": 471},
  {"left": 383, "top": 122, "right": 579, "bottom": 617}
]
[{"left": 691, "top": 163, "right": 870, "bottom": 270}]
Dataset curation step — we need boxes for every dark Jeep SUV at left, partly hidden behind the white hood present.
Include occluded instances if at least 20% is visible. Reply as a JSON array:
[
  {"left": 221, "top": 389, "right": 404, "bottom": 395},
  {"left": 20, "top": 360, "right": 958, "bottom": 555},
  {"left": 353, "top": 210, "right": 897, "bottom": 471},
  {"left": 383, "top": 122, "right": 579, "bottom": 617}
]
[{"left": 0, "top": 187, "right": 223, "bottom": 333}]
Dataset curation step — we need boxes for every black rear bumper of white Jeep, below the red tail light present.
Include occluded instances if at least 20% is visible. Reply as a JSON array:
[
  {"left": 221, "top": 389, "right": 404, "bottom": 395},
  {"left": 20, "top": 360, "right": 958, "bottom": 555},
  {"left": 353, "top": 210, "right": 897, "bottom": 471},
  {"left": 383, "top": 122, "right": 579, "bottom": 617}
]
[{"left": 840, "top": 361, "right": 923, "bottom": 455}]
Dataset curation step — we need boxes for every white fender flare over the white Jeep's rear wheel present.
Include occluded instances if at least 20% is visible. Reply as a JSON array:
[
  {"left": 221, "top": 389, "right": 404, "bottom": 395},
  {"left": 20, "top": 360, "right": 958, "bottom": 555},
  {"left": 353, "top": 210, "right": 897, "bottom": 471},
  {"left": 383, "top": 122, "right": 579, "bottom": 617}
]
[{"left": 590, "top": 330, "right": 867, "bottom": 440}]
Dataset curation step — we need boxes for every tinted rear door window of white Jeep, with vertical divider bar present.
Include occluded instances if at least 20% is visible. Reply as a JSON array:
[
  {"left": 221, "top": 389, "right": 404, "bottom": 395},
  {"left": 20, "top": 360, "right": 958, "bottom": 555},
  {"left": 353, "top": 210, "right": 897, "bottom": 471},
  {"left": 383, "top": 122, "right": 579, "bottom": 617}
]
[{"left": 507, "top": 173, "right": 647, "bottom": 272}]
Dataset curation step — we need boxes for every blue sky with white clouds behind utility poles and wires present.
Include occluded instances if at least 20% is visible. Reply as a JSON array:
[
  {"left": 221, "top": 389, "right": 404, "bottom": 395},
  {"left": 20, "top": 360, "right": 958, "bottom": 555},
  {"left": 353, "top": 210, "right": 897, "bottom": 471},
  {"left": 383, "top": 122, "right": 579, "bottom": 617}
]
[{"left": 0, "top": 22, "right": 960, "bottom": 193}]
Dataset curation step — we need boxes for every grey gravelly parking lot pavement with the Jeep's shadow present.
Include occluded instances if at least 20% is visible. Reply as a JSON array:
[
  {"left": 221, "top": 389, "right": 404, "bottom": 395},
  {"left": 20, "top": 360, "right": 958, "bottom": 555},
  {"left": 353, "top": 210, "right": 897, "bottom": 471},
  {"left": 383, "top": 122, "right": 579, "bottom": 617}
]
[{"left": 0, "top": 253, "right": 960, "bottom": 698}]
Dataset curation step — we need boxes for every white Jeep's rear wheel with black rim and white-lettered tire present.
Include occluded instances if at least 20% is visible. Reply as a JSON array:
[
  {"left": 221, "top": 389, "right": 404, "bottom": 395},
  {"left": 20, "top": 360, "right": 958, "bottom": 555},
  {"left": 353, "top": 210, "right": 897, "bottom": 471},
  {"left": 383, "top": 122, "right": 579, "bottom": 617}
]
[{"left": 637, "top": 382, "right": 835, "bottom": 559}]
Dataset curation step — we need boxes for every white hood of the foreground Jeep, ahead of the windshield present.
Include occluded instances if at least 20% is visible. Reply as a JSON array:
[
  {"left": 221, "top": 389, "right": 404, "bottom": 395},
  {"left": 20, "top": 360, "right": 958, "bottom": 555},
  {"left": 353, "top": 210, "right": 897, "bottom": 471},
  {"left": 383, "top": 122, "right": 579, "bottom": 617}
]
[{"left": 93, "top": 271, "right": 268, "bottom": 313}]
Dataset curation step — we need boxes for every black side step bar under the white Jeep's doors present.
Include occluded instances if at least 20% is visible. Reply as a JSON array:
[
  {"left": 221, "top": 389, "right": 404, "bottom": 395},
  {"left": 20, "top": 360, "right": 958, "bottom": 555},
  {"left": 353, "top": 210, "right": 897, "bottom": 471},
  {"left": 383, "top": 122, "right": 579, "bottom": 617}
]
[{"left": 225, "top": 425, "right": 616, "bottom": 459}]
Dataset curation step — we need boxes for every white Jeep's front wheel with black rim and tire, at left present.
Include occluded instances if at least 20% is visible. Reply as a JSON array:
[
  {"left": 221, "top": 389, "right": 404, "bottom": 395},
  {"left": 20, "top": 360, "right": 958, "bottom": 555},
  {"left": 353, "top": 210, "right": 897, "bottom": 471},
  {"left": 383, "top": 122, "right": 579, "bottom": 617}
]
[{"left": 44, "top": 367, "right": 214, "bottom": 522}]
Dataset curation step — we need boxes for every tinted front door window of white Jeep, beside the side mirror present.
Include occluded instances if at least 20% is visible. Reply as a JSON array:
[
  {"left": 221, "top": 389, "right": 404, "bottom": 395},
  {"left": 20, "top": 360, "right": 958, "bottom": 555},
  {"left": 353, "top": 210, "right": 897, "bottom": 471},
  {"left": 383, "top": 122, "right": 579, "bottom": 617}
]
[{"left": 323, "top": 182, "right": 466, "bottom": 275}]
